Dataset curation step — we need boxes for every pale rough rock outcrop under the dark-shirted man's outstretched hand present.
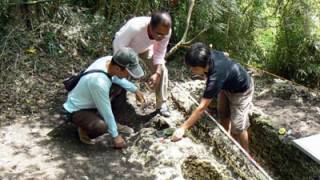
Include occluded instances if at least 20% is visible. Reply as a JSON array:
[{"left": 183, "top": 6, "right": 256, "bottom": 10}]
[{"left": 126, "top": 92, "right": 237, "bottom": 179}]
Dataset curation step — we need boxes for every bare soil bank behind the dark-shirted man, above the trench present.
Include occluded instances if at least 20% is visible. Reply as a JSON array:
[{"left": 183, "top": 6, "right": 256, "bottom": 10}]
[{"left": 175, "top": 72, "right": 320, "bottom": 139}]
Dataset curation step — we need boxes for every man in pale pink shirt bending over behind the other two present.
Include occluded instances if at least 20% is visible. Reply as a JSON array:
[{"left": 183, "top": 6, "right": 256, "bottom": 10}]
[{"left": 113, "top": 12, "right": 171, "bottom": 117}]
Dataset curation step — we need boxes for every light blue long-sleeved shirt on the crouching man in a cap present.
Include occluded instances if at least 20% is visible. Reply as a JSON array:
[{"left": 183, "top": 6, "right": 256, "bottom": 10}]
[{"left": 63, "top": 56, "right": 137, "bottom": 137}]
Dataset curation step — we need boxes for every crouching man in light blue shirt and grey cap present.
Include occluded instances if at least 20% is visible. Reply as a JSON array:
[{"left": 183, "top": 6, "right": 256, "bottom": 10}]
[{"left": 63, "top": 48, "right": 144, "bottom": 148}]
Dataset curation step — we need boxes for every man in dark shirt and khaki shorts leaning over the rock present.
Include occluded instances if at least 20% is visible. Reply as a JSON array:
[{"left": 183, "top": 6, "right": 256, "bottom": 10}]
[{"left": 172, "top": 43, "right": 254, "bottom": 152}]
